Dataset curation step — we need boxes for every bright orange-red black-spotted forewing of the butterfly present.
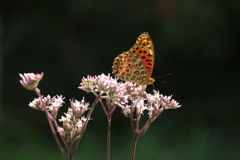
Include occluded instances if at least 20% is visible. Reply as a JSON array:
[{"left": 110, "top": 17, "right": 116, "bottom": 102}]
[{"left": 129, "top": 32, "right": 155, "bottom": 78}]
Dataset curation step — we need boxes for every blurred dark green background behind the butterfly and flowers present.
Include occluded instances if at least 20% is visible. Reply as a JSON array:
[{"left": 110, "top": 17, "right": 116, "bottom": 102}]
[{"left": 0, "top": 0, "right": 240, "bottom": 160}]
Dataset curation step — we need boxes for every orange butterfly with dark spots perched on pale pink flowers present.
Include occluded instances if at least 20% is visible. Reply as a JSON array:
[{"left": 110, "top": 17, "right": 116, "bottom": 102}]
[{"left": 112, "top": 32, "right": 155, "bottom": 85}]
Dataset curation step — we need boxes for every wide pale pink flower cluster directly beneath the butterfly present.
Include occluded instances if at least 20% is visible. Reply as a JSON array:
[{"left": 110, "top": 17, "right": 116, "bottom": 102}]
[{"left": 79, "top": 74, "right": 181, "bottom": 118}]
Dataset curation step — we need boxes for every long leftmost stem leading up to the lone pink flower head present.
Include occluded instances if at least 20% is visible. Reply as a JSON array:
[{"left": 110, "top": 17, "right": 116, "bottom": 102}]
[{"left": 34, "top": 88, "right": 68, "bottom": 160}]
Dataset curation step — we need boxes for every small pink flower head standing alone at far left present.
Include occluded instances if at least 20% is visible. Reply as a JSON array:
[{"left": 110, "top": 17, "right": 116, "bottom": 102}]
[{"left": 19, "top": 73, "right": 43, "bottom": 90}]
